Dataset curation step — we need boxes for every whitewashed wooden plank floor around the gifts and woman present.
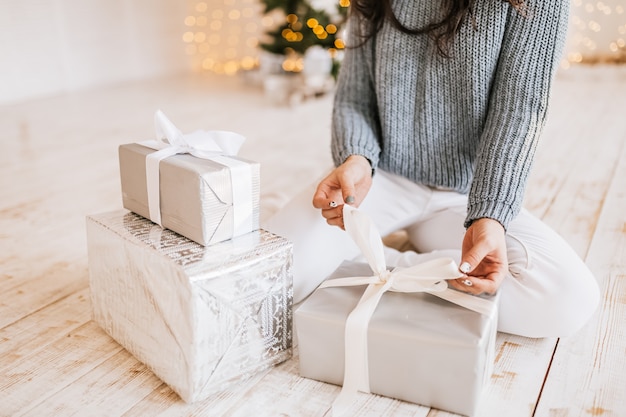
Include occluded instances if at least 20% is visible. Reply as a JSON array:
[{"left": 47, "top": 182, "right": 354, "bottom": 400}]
[{"left": 0, "top": 68, "right": 626, "bottom": 417}]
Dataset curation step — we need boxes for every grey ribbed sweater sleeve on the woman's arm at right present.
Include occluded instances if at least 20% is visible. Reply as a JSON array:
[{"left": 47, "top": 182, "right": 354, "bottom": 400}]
[{"left": 465, "top": 0, "right": 569, "bottom": 228}]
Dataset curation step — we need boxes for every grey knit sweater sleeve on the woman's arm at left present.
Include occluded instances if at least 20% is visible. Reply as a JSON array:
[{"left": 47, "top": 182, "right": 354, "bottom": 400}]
[{"left": 331, "top": 17, "right": 380, "bottom": 169}]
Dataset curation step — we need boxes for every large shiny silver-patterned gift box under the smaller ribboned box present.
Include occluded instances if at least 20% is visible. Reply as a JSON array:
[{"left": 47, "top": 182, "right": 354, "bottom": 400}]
[{"left": 87, "top": 210, "right": 292, "bottom": 402}]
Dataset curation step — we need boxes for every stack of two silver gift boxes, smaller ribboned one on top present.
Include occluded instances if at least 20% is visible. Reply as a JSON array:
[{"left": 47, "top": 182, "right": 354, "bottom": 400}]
[{"left": 87, "top": 113, "right": 292, "bottom": 402}]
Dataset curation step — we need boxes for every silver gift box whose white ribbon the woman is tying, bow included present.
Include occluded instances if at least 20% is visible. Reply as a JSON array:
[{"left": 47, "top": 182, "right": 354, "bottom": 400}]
[{"left": 294, "top": 205, "right": 497, "bottom": 417}]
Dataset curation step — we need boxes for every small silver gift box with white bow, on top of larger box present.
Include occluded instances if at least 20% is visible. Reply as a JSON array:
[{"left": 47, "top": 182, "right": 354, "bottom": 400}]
[{"left": 119, "top": 111, "right": 260, "bottom": 245}]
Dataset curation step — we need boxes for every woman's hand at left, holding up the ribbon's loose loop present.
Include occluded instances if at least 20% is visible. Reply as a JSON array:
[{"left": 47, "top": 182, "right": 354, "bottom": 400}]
[{"left": 313, "top": 155, "right": 372, "bottom": 229}]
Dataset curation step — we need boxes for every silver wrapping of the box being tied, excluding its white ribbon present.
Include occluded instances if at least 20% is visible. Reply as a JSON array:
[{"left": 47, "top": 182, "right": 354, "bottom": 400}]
[{"left": 294, "top": 261, "right": 497, "bottom": 416}]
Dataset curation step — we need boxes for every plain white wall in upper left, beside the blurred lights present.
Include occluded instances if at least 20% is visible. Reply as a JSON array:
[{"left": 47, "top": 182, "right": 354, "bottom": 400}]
[{"left": 0, "top": 0, "right": 190, "bottom": 104}]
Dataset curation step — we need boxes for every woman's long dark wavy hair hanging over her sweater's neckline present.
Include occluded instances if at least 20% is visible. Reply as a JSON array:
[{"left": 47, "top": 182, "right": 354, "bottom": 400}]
[{"left": 351, "top": 0, "right": 525, "bottom": 57}]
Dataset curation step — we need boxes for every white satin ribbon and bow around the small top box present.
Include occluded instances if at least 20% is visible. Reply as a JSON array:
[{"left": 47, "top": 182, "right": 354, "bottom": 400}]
[{"left": 140, "top": 110, "right": 253, "bottom": 236}]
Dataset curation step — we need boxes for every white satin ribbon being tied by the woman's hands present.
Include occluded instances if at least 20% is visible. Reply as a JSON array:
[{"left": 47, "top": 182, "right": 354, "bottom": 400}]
[{"left": 320, "top": 204, "right": 492, "bottom": 416}]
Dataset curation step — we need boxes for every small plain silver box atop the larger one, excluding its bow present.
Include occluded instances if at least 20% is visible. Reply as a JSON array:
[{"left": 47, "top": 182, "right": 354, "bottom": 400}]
[{"left": 119, "top": 143, "right": 260, "bottom": 245}]
